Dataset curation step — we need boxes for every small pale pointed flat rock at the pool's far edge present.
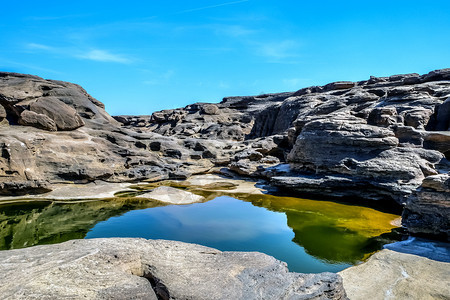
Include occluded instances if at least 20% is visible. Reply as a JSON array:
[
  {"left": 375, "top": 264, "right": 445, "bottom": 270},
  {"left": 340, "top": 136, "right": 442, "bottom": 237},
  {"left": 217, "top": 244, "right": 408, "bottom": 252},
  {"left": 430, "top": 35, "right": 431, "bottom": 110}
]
[{"left": 137, "top": 186, "right": 205, "bottom": 204}]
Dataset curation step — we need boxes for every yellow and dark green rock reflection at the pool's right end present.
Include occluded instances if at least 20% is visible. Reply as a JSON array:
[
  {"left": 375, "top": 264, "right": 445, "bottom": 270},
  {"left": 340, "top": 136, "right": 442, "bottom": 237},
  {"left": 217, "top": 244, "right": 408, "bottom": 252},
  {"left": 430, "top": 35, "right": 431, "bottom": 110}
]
[{"left": 248, "top": 195, "right": 398, "bottom": 264}]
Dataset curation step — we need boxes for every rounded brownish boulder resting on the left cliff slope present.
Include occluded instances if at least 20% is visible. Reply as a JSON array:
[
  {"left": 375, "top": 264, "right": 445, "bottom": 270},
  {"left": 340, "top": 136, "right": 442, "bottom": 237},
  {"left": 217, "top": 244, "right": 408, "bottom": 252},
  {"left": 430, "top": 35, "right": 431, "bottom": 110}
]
[{"left": 30, "top": 97, "right": 84, "bottom": 130}]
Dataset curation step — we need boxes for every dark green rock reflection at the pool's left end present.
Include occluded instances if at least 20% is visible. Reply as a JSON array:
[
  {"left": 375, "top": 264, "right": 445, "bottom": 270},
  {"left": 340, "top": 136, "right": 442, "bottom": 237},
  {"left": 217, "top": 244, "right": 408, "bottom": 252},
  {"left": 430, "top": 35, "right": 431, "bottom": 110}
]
[{"left": 0, "top": 199, "right": 158, "bottom": 250}]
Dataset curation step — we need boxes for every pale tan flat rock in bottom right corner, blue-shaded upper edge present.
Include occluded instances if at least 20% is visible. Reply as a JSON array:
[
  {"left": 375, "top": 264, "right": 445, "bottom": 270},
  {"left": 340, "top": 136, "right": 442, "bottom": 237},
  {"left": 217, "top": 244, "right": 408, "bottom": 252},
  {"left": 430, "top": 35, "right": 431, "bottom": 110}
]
[{"left": 339, "top": 241, "right": 450, "bottom": 300}]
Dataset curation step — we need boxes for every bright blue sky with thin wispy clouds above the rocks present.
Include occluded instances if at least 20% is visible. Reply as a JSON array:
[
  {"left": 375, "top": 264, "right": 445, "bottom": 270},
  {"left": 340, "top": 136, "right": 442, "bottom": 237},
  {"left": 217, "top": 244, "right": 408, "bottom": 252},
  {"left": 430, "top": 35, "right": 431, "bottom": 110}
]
[{"left": 0, "top": 0, "right": 450, "bottom": 115}]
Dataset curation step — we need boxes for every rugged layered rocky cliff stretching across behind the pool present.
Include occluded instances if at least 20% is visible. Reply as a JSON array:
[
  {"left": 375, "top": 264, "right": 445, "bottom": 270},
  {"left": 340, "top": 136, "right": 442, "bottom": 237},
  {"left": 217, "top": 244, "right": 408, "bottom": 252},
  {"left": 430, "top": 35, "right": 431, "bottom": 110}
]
[{"left": 0, "top": 69, "right": 450, "bottom": 238}]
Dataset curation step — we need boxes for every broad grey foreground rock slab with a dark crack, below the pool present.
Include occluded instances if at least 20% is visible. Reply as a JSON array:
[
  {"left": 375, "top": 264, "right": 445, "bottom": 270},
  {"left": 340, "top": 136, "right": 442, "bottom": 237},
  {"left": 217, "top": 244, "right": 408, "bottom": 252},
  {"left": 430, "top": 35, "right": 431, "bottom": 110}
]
[{"left": 0, "top": 239, "right": 347, "bottom": 299}]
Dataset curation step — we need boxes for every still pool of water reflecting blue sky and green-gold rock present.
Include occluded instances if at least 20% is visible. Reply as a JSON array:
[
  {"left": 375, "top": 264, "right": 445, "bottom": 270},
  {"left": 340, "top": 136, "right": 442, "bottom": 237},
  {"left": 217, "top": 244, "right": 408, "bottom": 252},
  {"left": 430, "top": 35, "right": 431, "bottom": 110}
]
[{"left": 0, "top": 194, "right": 398, "bottom": 272}]
